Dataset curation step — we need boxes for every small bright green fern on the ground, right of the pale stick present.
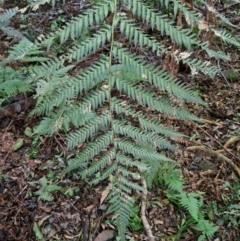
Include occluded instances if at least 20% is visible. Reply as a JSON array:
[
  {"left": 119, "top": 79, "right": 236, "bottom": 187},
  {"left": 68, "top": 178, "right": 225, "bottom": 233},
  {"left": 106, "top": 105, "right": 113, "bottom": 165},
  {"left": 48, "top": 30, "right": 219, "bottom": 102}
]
[{"left": 154, "top": 163, "right": 218, "bottom": 241}]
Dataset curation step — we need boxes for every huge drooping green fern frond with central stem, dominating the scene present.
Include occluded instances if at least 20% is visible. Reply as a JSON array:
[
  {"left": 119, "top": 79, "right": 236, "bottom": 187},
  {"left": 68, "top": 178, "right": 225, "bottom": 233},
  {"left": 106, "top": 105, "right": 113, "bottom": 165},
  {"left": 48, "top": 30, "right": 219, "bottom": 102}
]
[{"left": 3, "top": 0, "right": 238, "bottom": 240}]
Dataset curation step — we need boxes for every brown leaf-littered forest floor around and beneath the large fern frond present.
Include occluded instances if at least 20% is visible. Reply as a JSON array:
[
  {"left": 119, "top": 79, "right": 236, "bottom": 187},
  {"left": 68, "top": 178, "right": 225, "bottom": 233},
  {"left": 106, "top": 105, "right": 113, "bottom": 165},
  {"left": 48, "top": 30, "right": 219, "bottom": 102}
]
[{"left": 0, "top": 1, "right": 240, "bottom": 241}]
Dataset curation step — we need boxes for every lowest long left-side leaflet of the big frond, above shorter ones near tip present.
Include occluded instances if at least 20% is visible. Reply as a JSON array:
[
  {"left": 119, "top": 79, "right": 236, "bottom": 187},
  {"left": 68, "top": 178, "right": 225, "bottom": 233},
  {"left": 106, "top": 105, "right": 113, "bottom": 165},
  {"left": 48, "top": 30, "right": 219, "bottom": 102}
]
[{"left": 65, "top": 131, "right": 112, "bottom": 173}]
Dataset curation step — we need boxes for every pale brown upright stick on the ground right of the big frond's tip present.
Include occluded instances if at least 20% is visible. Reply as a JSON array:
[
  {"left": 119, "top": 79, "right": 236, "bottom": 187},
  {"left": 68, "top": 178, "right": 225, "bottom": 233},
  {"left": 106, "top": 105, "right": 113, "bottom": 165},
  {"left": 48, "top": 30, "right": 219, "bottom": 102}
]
[{"left": 141, "top": 177, "right": 155, "bottom": 241}]
